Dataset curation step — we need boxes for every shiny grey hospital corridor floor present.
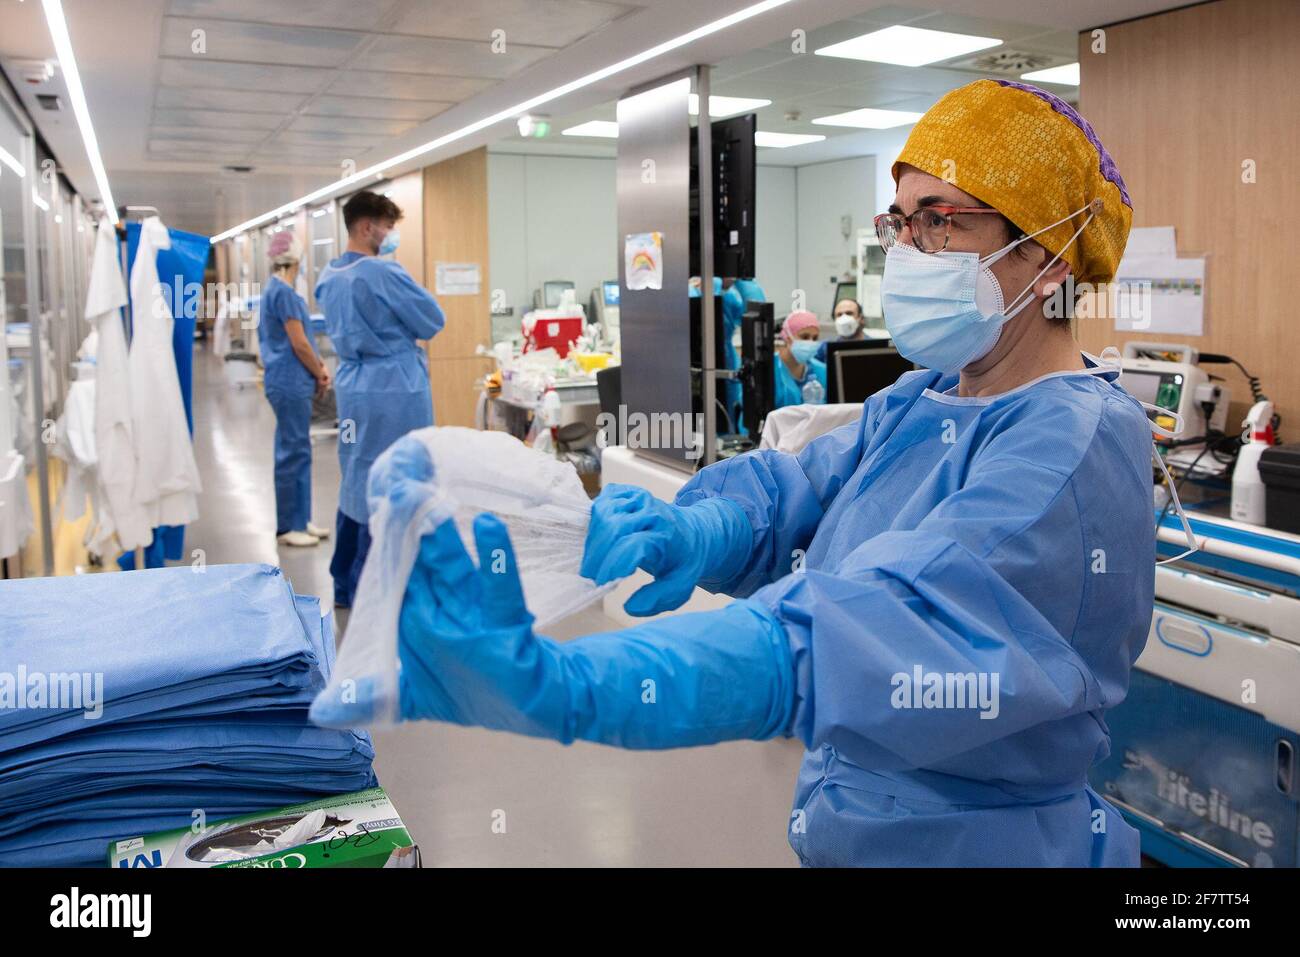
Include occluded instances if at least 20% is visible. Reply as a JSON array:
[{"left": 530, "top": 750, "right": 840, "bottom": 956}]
[{"left": 186, "top": 346, "right": 802, "bottom": 867}]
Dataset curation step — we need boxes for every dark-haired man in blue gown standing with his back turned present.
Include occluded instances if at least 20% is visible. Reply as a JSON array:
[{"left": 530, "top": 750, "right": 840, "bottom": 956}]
[{"left": 316, "top": 190, "right": 443, "bottom": 607}]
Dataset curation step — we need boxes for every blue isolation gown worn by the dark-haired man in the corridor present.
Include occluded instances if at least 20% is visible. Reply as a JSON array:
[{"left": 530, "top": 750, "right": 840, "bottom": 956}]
[{"left": 316, "top": 252, "right": 445, "bottom": 524}]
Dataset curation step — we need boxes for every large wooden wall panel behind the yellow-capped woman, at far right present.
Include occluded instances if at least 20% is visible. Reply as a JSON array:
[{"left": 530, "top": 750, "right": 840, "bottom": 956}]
[{"left": 1079, "top": 0, "right": 1300, "bottom": 429}]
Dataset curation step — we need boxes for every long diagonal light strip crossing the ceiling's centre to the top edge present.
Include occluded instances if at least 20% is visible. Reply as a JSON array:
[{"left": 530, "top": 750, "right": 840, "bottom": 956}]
[{"left": 209, "top": 0, "right": 792, "bottom": 243}]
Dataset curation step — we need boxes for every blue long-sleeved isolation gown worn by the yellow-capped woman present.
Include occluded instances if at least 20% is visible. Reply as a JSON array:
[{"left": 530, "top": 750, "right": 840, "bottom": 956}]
[{"left": 677, "top": 358, "right": 1156, "bottom": 866}]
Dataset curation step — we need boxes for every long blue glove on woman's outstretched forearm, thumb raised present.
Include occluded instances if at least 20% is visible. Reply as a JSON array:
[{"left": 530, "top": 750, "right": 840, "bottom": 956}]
[{"left": 398, "top": 515, "right": 794, "bottom": 748}]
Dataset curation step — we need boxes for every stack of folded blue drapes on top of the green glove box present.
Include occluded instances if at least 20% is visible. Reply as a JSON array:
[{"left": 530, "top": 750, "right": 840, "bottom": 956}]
[{"left": 0, "top": 564, "right": 374, "bottom": 866}]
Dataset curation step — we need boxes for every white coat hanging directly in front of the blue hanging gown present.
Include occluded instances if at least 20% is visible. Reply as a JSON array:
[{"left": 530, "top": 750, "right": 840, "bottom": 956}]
[{"left": 130, "top": 216, "right": 202, "bottom": 527}]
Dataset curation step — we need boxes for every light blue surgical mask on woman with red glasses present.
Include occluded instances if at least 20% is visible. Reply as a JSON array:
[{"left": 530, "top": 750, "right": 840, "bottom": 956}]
[{"left": 880, "top": 204, "right": 1095, "bottom": 372}]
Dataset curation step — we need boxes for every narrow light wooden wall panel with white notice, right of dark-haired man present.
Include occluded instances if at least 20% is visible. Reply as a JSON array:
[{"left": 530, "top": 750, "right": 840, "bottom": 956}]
[{"left": 424, "top": 148, "right": 491, "bottom": 425}]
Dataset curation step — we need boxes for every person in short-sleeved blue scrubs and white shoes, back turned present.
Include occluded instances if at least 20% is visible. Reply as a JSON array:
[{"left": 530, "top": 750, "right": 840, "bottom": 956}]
[{"left": 257, "top": 230, "right": 330, "bottom": 547}]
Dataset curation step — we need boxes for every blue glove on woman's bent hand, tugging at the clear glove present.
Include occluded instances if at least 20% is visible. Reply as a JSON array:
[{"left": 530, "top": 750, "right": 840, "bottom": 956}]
[{"left": 580, "top": 484, "right": 754, "bottom": 616}]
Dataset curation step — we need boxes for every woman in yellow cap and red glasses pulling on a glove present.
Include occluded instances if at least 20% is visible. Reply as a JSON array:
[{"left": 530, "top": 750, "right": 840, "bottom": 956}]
[{"left": 377, "top": 79, "right": 1156, "bottom": 866}]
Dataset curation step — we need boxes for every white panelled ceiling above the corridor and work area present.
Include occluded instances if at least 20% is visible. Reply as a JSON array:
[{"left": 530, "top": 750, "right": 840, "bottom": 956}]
[{"left": 0, "top": 0, "right": 1178, "bottom": 233}]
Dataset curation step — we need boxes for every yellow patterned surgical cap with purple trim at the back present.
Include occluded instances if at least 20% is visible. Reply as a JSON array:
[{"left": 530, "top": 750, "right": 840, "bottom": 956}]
[{"left": 893, "top": 79, "right": 1132, "bottom": 283}]
